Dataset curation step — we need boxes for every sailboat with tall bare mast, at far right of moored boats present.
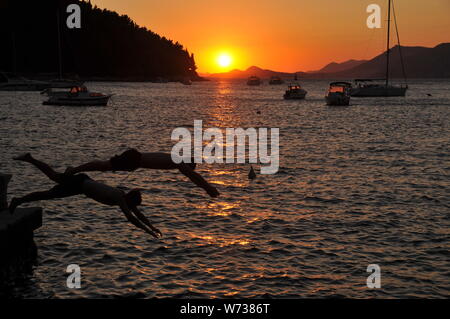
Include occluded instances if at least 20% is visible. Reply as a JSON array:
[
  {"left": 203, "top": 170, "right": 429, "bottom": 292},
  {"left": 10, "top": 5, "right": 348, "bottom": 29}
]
[{"left": 350, "top": 0, "right": 408, "bottom": 97}]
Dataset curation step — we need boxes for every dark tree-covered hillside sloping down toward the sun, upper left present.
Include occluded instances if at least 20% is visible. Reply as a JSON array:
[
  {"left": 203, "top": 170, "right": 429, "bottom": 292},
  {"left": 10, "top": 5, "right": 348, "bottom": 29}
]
[{"left": 0, "top": 0, "right": 197, "bottom": 80}]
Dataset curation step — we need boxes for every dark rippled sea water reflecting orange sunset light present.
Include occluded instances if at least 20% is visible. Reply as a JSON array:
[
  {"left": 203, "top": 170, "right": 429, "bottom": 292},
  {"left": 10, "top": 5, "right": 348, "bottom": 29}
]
[{"left": 0, "top": 80, "right": 450, "bottom": 298}]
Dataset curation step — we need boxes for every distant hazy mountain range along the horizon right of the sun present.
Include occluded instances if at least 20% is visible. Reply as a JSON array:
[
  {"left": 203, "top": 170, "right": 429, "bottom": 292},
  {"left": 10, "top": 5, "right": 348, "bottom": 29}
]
[{"left": 207, "top": 43, "right": 450, "bottom": 79}]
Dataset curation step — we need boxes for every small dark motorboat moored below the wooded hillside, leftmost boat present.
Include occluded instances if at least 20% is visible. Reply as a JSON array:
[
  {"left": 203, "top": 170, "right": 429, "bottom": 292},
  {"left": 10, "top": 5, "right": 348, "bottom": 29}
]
[{"left": 42, "top": 85, "right": 112, "bottom": 106}]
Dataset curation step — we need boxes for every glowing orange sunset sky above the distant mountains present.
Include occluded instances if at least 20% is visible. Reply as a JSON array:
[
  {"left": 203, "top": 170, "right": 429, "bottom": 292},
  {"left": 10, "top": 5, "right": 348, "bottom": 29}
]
[{"left": 91, "top": 0, "right": 450, "bottom": 73}]
